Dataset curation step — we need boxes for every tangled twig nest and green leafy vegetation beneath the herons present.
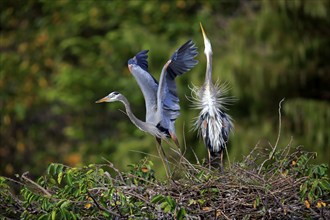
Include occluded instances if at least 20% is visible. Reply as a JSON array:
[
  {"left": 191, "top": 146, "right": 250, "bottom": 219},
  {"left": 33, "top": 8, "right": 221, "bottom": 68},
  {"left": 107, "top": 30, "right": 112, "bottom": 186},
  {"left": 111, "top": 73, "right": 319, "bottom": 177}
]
[{"left": 0, "top": 144, "right": 330, "bottom": 219}]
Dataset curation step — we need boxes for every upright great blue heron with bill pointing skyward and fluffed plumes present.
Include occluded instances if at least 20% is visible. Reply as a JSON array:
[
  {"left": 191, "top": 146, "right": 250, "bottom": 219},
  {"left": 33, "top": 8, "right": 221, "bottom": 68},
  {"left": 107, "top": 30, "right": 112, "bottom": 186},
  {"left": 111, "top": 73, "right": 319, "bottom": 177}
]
[{"left": 192, "top": 24, "right": 233, "bottom": 171}]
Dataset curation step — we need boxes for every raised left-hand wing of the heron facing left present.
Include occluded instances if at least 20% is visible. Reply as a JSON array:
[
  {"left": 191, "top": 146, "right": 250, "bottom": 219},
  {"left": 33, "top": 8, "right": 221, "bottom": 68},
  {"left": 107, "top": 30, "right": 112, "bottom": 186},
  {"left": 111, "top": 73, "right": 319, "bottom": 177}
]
[{"left": 128, "top": 50, "right": 158, "bottom": 123}]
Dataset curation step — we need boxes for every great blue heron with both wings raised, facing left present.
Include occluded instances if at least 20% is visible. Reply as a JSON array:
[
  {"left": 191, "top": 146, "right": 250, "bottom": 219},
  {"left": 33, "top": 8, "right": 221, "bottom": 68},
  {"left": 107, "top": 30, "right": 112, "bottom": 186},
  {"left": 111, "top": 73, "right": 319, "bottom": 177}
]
[{"left": 97, "top": 40, "right": 198, "bottom": 175}]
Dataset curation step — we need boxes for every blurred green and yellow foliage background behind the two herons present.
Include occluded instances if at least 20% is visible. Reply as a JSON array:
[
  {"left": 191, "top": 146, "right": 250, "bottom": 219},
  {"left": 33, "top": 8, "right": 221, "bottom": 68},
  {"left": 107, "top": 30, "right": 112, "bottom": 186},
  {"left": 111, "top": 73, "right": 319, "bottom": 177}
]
[{"left": 0, "top": 0, "right": 330, "bottom": 176}]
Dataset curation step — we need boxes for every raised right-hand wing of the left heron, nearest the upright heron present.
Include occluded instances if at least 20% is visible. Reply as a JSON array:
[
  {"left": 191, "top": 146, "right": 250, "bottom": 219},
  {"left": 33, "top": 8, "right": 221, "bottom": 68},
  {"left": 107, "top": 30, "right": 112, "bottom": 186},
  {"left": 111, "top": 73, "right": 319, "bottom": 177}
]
[{"left": 157, "top": 40, "right": 198, "bottom": 129}]
